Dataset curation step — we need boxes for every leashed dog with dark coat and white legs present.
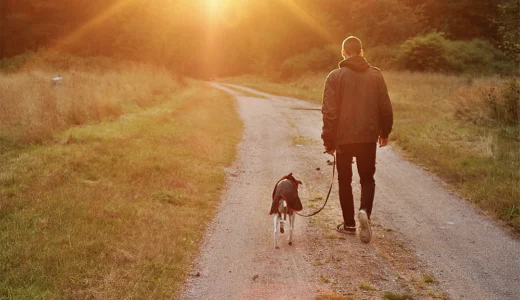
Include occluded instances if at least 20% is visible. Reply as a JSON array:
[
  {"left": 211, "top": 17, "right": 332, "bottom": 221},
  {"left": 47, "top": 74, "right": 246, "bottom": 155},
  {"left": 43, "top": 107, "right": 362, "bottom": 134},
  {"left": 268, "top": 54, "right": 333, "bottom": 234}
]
[{"left": 270, "top": 173, "right": 303, "bottom": 249}]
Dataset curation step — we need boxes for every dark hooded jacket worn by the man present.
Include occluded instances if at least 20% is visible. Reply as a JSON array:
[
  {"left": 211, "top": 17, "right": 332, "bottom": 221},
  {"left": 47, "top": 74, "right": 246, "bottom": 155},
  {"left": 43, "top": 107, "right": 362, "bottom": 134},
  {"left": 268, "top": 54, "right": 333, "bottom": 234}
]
[{"left": 321, "top": 56, "right": 393, "bottom": 149}]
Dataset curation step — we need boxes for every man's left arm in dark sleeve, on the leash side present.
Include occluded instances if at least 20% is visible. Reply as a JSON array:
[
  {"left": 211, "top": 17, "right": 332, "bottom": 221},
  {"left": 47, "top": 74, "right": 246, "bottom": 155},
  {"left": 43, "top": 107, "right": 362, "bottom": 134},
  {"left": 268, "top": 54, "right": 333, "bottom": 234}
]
[{"left": 321, "top": 72, "right": 339, "bottom": 153}]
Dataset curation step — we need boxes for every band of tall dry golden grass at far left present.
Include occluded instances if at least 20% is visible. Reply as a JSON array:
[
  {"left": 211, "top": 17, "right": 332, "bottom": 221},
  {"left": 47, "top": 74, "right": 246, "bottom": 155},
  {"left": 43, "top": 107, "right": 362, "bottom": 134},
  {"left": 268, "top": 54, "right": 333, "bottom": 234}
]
[{"left": 0, "top": 65, "right": 179, "bottom": 142}]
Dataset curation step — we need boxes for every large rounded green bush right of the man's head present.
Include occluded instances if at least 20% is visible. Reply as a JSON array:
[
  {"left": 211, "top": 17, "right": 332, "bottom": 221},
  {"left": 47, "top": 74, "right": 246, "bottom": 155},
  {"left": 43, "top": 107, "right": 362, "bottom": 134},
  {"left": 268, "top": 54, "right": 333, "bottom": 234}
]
[{"left": 397, "top": 32, "right": 516, "bottom": 74}]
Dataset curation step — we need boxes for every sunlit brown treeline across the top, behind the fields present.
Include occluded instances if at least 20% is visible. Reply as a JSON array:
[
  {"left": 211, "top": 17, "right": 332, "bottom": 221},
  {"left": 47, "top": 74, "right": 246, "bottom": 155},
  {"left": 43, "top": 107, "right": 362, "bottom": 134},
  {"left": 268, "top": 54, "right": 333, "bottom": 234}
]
[{"left": 0, "top": 0, "right": 520, "bottom": 76}]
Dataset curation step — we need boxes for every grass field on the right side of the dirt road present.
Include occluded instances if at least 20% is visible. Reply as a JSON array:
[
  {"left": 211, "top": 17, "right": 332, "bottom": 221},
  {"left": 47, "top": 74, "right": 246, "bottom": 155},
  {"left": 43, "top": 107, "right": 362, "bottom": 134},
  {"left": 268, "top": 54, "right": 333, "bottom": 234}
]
[{"left": 223, "top": 72, "right": 520, "bottom": 232}]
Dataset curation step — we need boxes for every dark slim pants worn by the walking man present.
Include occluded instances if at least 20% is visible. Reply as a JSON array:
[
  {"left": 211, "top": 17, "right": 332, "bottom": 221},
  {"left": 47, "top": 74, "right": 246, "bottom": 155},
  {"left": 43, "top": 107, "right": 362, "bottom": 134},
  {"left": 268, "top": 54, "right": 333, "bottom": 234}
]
[{"left": 337, "top": 143, "right": 377, "bottom": 226}]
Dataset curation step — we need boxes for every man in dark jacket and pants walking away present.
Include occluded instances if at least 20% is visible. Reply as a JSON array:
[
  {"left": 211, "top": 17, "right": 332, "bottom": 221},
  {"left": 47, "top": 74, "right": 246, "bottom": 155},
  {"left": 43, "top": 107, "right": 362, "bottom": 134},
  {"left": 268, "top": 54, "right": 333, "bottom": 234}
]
[{"left": 321, "top": 36, "right": 393, "bottom": 243}]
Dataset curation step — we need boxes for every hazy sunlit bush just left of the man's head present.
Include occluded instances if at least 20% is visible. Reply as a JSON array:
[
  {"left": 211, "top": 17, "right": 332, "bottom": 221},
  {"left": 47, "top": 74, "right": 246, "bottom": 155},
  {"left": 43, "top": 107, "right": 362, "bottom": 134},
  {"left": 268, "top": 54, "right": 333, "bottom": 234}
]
[{"left": 280, "top": 45, "right": 341, "bottom": 79}]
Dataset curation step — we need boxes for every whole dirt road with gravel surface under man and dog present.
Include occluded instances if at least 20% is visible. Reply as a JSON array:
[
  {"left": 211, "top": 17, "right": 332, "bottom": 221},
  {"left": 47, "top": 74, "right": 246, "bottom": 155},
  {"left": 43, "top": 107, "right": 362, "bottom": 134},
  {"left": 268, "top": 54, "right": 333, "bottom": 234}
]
[{"left": 181, "top": 84, "right": 520, "bottom": 299}]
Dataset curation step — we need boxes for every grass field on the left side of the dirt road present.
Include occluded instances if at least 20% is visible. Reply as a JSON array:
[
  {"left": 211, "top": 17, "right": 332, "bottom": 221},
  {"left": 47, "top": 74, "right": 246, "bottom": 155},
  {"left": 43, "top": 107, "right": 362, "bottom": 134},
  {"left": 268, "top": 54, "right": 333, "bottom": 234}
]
[{"left": 0, "top": 74, "right": 242, "bottom": 299}]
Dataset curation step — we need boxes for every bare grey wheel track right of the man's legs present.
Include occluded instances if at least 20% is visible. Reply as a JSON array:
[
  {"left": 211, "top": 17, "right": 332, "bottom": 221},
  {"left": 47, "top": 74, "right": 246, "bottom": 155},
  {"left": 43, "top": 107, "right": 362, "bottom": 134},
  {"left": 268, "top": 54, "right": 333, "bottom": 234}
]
[{"left": 376, "top": 151, "right": 520, "bottom": 300}]
